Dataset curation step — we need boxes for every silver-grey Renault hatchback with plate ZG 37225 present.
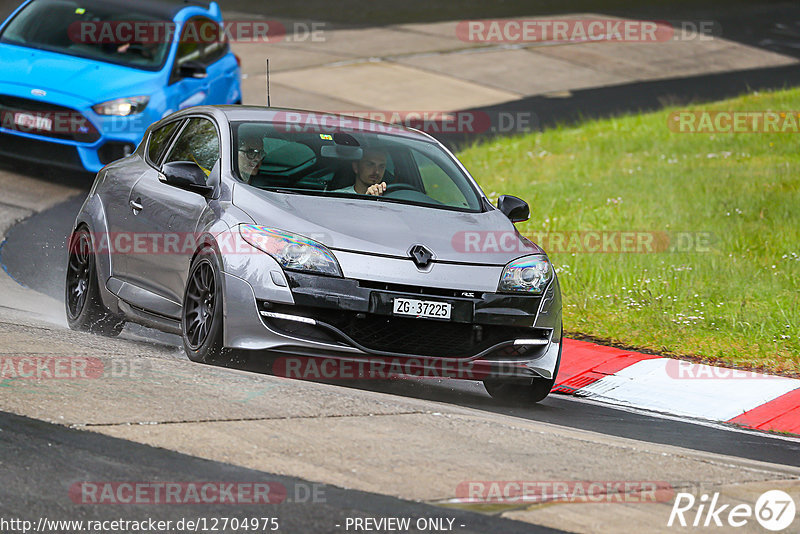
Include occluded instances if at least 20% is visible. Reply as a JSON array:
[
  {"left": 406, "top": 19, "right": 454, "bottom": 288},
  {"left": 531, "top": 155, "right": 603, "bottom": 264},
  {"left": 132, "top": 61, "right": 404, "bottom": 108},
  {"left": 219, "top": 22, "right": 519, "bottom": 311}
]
[{"left": 65, "top": 106, "right": 562, "bottom": 402}]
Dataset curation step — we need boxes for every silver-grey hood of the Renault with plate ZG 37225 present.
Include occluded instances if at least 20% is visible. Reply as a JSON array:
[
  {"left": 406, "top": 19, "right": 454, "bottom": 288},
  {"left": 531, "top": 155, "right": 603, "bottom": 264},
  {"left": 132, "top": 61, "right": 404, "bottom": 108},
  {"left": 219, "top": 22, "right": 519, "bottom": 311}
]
[{"left": 233, "top": 185, "right": 542, "bottom": 265}]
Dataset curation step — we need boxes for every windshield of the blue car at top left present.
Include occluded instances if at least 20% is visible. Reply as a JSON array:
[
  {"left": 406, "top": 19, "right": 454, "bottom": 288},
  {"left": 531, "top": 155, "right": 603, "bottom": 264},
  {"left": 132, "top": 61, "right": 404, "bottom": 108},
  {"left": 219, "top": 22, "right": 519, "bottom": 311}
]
[{"left": 0, "top": 0, "right": 174, "bottom": 70}]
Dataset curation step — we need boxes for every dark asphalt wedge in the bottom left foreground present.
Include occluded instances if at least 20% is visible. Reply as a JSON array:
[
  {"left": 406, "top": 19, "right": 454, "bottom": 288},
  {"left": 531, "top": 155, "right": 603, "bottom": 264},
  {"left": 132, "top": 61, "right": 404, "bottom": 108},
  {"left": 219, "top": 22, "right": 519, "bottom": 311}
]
[{"left": 0, "top": 412, "right": 561, "bottom": 534}]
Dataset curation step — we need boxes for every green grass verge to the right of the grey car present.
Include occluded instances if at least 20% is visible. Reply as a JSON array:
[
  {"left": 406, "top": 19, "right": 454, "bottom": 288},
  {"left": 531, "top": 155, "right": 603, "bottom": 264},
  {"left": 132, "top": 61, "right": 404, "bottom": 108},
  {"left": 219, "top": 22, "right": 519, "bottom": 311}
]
[{"left": 459, "top": 89, "right": 800, "bottom": 375}]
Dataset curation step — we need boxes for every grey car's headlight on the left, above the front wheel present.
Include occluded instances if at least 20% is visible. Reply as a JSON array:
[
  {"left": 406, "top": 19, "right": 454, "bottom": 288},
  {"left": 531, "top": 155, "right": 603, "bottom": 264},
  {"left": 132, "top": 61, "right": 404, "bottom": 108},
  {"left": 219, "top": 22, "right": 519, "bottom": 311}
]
[{"left": 234, "top": 224, "right": 342, "bottom": 276}]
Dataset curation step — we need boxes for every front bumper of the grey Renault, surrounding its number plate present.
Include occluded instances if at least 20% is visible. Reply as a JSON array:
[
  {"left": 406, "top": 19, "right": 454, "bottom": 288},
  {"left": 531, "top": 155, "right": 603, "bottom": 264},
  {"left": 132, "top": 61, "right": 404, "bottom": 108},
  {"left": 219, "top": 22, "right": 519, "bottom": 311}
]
[{"left": 219, "top": 273, "right": 562, "bottom": 379}]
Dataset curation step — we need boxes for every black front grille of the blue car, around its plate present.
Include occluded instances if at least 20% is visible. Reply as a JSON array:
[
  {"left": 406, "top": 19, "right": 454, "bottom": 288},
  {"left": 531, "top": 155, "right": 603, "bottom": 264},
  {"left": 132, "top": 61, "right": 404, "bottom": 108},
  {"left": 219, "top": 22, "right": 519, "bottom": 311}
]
[{"left": 0, "top": 95, "right": 100, "bottom": 143}]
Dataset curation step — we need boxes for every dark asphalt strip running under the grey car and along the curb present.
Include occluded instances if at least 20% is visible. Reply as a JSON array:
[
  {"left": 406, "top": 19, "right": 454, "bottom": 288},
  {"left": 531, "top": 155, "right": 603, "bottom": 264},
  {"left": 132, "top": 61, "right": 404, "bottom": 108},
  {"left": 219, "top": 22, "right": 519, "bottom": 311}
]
[{"left": 0, "top": 193, "right": 800, "bottom": 466}]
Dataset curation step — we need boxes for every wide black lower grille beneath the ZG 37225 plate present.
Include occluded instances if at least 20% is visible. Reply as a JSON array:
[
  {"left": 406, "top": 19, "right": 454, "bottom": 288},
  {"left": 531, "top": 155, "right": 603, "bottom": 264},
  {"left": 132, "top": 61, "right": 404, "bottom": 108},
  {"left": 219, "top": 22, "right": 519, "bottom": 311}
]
[{"left": 262, "top": 304, "right": 547, "bottom": 358}]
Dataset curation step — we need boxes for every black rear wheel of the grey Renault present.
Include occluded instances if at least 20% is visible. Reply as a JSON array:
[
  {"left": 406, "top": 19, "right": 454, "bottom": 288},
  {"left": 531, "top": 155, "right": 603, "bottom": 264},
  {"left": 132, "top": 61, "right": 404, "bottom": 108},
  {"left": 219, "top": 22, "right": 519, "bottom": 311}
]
[{"left": 64, "top": 227, "right": 125, "bottom": 337}]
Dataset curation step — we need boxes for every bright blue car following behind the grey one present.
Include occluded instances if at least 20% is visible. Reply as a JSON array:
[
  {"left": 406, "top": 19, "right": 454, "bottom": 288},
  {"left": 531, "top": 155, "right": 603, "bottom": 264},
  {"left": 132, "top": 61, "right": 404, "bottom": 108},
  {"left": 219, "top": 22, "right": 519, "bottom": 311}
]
[{"left": 0, "top": 0, "right": 242, "bottom": 172}]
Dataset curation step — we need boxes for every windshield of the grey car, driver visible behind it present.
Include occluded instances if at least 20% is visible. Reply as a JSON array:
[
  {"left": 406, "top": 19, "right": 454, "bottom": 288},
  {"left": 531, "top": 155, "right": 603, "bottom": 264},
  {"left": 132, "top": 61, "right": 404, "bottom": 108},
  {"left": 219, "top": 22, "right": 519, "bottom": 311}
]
[{"left": 233, "top": 122, "right": 482, "bottom": 212}]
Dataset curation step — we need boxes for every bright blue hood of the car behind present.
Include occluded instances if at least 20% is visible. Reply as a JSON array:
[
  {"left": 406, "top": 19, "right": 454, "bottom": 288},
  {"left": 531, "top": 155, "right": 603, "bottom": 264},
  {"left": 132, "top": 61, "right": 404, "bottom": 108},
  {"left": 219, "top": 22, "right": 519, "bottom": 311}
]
[{"left": 0, "top": 43, "right": 158, "bottom": 103}]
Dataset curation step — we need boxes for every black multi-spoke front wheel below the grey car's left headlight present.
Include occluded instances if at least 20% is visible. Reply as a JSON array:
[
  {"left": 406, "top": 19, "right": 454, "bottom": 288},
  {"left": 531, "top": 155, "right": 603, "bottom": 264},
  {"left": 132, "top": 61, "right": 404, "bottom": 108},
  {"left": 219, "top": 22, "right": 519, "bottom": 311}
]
[{"left": 181, "top": 247, "right": 230, "bottom": 364}]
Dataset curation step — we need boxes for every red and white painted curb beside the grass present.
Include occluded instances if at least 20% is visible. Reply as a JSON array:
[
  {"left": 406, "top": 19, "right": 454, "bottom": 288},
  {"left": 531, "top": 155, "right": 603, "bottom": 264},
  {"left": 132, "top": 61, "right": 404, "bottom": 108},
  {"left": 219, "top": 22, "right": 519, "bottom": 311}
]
[{"left": 553, "top": 339, "right": 800, "bottom": 434}]
